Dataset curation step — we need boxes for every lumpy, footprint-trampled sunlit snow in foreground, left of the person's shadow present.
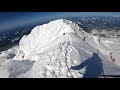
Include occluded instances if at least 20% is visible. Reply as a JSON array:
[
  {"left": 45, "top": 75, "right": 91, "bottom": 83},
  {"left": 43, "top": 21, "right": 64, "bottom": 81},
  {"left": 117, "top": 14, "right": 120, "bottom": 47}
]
[{"left": 17, "top": 39, "right": 82, "bottom": 78}]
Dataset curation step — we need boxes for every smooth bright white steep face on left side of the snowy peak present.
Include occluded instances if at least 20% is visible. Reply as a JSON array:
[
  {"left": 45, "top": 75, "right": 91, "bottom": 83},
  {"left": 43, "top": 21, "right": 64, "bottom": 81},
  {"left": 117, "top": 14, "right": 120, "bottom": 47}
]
[{"left": 20, "top": 19, "right": 76, "bottom": 59}]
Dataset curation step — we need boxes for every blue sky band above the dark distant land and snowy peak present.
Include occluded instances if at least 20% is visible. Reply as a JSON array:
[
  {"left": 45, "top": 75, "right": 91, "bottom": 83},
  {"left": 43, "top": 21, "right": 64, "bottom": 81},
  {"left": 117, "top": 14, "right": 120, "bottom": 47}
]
[{"left": 0, "top": 12, "right": 120, "bottom": 31}]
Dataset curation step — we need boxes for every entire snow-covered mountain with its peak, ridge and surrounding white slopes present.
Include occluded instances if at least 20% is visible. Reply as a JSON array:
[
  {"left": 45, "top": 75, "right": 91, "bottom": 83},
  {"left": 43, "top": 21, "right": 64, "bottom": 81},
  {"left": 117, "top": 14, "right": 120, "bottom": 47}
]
[{"left": 0, "top": 19, "right": 120, "bottom": 78}]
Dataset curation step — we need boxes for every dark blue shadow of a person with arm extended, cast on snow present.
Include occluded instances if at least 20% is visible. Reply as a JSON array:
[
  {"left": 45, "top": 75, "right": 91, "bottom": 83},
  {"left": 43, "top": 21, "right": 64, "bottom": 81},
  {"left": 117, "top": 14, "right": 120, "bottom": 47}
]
[{"left": 71, "top": 53, "right": 103, "bottom": 78}]
